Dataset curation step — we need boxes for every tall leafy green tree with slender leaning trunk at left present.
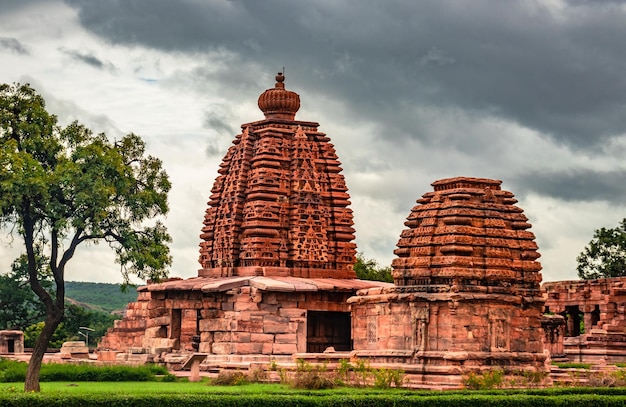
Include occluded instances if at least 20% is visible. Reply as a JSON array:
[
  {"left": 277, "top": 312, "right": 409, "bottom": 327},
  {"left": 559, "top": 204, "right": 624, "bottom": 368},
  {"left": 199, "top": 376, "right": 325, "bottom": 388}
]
[{"left": 0, "top": 84, "right": 171, "bottom": 391}]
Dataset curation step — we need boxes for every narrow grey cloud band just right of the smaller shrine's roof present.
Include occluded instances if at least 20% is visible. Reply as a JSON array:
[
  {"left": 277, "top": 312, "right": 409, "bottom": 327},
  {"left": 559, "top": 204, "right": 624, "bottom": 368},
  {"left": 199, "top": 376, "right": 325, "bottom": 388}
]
[{"left": 510, "top": 169, "right": 626, "bottom": 203}]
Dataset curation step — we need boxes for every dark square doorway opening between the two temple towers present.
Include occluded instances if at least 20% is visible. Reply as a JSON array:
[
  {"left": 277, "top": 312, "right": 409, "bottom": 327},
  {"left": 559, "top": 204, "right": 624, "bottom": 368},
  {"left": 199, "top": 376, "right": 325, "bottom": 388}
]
[{"left": 306, "top": 311, "right": 352, "bottom": 353}]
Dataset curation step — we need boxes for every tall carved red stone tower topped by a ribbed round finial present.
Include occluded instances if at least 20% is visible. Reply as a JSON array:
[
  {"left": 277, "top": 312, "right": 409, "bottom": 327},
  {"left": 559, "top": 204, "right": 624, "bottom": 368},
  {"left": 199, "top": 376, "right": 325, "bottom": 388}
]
[{"left": 198, "top": 73, "right": 356, "bottom": 278}]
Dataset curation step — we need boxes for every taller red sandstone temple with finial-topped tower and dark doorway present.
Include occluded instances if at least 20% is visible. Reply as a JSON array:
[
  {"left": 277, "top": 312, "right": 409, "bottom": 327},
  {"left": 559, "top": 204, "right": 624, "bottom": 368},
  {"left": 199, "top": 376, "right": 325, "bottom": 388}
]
[{"left": 100, "top": 74, "right": 389, "bottom": 359}]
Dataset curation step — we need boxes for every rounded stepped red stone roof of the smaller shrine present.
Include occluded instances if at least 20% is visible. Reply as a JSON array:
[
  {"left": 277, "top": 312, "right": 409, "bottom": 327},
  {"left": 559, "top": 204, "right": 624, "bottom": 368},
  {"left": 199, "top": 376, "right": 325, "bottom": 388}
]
[{"left": 392, "top": 177, "right": 541, "bottom": 296}]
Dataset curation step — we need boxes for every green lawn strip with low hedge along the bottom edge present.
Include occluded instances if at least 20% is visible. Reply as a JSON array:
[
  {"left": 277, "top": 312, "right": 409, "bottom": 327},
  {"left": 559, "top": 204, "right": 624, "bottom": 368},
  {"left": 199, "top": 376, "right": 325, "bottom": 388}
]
[{"left": 0, "top": 381, "right": 626, "bottom": 407}]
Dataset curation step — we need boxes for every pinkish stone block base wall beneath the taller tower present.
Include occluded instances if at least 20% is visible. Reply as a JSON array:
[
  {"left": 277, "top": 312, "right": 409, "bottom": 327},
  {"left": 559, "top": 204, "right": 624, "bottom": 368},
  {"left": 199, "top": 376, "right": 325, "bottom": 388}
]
[{"left": 100, "top": 287, "right": 353, "bottom": 355}]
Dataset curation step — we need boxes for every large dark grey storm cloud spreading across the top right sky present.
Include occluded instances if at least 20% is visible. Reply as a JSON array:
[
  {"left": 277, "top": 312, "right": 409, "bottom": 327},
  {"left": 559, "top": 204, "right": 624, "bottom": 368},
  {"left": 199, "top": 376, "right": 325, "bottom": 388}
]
[{"left": 62, "top": 0, "right": 626, "bottom": 148}]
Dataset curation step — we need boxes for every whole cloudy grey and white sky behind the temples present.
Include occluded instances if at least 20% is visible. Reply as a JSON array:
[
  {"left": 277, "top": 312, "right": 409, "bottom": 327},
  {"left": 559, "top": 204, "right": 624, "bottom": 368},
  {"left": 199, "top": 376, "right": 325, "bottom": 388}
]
[{"left": 0, "top": 0, "right": 626, "bottom": 282}]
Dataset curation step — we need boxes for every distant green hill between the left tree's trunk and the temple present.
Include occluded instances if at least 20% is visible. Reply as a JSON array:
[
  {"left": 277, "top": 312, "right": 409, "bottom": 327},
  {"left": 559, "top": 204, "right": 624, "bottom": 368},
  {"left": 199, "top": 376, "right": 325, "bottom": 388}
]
[{"left": 65, "top": 281, "right": 137, "bottom": 313}]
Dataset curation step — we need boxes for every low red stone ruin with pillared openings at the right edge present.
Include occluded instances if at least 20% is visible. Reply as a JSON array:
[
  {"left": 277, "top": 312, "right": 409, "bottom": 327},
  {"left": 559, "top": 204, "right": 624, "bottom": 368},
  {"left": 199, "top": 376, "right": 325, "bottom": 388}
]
[{"left": 543, "top": 277, "right": 626, "bottom": 363}]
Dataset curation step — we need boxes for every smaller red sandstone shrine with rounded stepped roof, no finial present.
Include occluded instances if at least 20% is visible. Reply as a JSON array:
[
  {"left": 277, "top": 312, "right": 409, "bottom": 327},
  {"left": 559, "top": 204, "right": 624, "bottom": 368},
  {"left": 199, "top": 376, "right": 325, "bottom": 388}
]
[{"left": 348, "top": 177, "right": 547, "bottom": 384}]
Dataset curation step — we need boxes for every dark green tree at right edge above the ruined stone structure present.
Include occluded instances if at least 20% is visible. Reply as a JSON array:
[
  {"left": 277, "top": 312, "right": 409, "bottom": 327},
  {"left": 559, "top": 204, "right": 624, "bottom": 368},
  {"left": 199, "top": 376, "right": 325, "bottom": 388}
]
[{"left": 576, "top": 219, "right": 626, "bottom": 280}]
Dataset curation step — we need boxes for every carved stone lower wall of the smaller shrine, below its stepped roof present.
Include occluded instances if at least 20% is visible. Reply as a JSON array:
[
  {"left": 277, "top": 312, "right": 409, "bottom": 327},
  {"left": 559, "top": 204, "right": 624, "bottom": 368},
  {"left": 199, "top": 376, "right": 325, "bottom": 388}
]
[{"left": 350, "top": 296, "right": 543, "bottom": 367}]
